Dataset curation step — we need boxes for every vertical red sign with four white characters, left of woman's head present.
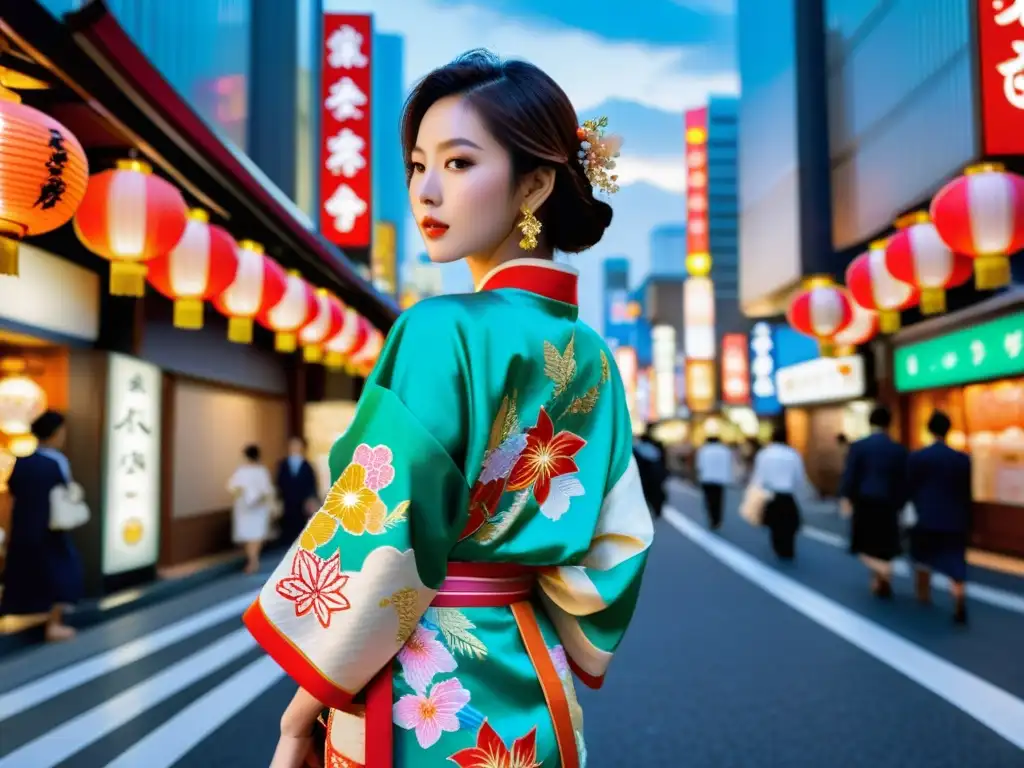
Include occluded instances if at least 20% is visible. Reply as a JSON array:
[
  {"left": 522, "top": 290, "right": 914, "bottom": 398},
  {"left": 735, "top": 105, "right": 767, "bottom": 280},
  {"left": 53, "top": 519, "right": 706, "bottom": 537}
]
[{"left": 319, "top": 13, "right": 374, "bottom": 248}]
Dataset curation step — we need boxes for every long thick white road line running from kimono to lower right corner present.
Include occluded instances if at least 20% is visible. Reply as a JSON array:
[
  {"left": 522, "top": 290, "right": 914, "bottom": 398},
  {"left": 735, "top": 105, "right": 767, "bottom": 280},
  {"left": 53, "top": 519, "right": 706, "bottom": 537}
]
[{"left": 665, "top": 508, "right": 1024, "bottom": 750}]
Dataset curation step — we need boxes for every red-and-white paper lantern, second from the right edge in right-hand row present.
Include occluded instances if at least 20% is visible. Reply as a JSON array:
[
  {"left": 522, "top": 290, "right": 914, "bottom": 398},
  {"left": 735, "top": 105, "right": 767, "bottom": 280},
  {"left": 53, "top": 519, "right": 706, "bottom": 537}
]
[{"left": 886, "top": 211, "right": 974, "bottom": 314}]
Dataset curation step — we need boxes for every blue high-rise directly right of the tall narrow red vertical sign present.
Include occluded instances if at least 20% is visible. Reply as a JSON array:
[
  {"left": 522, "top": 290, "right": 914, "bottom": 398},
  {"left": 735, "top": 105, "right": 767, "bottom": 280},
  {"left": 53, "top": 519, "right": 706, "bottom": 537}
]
[{"left": 708, "top": 96, "right": 744, "bottom": 337}]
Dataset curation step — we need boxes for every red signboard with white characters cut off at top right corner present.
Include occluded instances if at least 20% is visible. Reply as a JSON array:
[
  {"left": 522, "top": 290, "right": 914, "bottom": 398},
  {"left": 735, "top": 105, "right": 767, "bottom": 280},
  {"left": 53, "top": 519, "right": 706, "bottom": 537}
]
[{"left": 977, "top": 0, "right": 1024, "bottom": 156}]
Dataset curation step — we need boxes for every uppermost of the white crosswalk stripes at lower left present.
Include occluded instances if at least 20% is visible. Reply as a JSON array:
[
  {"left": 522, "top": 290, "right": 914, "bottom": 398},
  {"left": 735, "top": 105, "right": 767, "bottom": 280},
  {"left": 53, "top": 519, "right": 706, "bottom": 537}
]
[{"left": 0, "top": 592, "right": 258, "bottom": 723}]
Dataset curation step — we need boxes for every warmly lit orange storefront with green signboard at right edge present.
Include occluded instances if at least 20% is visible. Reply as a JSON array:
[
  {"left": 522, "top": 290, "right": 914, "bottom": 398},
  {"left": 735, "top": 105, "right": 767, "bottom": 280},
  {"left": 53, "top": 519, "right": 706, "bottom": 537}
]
[{"left": 894, "top": 288, "right": 1024, "bottom": 555}]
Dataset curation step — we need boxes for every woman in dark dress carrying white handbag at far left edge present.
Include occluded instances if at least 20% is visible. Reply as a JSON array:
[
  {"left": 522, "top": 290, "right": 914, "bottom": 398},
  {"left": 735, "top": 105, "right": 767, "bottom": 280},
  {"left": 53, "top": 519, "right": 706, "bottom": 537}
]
[{"left": 0, "top": 411, "right": 83, "bottom": 642}]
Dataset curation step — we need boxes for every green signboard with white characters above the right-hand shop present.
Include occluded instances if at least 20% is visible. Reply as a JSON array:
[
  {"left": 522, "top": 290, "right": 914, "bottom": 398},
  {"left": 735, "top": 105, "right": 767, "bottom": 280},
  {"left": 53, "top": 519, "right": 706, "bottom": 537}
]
[{"left": 896, "top": 312, "right": 1024, "bottom": 392}]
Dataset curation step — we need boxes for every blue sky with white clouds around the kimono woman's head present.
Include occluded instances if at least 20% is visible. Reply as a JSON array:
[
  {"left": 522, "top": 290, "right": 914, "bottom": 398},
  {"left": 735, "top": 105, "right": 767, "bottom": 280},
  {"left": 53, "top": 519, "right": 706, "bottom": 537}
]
[{"left": 325, "top": 0, "right": 738, "bottom": 327}]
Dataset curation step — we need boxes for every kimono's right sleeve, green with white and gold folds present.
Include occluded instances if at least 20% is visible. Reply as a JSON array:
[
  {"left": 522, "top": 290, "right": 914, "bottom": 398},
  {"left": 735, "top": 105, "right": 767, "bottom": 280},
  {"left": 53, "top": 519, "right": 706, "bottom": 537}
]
[{"left": 541, "top": 364, "right": 654, "bottom": 688}]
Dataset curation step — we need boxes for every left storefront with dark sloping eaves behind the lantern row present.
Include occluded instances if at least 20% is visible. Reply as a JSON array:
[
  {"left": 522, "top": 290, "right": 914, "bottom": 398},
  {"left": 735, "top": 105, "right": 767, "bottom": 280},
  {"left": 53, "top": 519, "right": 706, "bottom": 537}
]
[{"left": 0, "top": 0, "right": 397, "bottom": 595}]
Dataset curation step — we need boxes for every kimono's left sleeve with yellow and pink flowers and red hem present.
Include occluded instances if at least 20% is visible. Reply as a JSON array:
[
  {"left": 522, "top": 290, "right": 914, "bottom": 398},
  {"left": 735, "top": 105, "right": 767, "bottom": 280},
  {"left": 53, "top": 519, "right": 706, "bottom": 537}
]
[{"left": 244, "top": 303, "right": 468, "bottom": 709}]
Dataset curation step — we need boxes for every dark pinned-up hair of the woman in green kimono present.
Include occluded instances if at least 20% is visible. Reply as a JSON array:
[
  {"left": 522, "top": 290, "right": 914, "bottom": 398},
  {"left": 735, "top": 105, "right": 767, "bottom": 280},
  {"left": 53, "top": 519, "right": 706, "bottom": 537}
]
[{"left": 401, "top": 49, "right": 611, "bottom": 253}]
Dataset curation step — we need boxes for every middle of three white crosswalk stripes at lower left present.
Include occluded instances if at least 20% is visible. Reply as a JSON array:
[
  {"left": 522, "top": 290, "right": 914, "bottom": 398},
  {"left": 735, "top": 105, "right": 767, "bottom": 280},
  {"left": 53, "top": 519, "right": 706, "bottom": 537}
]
[{"left": 0, "top": 629, "right": 257, "bottom": 768}]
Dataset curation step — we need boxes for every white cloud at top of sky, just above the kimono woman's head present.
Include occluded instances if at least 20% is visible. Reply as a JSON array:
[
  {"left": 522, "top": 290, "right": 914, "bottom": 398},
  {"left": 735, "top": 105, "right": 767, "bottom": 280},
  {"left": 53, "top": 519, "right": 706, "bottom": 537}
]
[{"left": 325, "top": 0, "right": 738, "bottom": 112}]
